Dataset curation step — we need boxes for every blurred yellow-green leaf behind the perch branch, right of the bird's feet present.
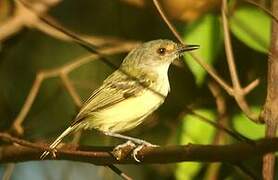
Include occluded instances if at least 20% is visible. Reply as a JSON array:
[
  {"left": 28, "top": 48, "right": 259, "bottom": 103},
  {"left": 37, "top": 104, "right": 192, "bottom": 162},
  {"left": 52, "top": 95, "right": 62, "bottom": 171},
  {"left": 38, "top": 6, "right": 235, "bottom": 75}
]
[{"left": 175, "top": 109, "right": 215, "bottom": 180}]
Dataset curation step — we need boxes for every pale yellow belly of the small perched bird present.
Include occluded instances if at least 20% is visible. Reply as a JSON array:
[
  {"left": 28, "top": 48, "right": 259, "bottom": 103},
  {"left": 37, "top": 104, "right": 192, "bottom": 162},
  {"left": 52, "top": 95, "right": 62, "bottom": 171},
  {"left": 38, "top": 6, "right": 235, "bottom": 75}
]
[{"left": 85, "top": 90, "right": 165, "bottom": 132}]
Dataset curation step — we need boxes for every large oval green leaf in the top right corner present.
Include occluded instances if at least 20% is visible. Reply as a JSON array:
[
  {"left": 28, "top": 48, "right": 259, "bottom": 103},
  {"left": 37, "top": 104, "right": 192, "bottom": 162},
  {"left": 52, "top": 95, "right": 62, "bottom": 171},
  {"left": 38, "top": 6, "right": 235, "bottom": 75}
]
[{"left": 230, "top": 6, "right": 271, "bottom": 53}]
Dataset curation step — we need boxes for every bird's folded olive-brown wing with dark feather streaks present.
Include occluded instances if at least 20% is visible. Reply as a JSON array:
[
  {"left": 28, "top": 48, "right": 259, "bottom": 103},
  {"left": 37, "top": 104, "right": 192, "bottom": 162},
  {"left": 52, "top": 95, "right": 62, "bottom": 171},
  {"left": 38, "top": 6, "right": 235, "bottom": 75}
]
[{"left": 72, "top": 71, "right": 150, "bottom": 125}]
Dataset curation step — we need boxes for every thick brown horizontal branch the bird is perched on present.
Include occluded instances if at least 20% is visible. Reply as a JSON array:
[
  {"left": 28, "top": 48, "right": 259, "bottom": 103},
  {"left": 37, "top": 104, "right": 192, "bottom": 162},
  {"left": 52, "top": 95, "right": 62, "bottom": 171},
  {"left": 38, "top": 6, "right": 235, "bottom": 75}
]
[{"left": 0, "top": 133, "right": 278, "bottom": 165}]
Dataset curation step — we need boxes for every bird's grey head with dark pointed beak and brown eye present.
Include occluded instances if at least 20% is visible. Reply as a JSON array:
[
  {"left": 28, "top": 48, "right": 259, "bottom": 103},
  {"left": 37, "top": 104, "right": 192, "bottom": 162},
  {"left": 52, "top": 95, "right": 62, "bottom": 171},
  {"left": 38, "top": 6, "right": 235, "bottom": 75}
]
[{"left": 122, "top": 39, "right": 199, "bottom": 73}]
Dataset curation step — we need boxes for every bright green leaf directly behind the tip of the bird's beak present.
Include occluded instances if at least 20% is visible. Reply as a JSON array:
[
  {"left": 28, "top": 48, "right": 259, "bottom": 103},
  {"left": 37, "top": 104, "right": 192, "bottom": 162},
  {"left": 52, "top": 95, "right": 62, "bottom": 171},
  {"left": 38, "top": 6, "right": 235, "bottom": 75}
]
[{"left": 184, "top": 14, "right": 223, "bottom": 85}]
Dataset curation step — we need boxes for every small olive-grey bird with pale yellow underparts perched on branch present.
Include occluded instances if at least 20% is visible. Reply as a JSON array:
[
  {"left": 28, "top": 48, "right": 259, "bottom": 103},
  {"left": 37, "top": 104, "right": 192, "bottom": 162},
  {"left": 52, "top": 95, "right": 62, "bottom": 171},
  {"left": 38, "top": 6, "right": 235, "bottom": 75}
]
[{"left": 41, "top": 39, "right": 199, "bottom": 159}]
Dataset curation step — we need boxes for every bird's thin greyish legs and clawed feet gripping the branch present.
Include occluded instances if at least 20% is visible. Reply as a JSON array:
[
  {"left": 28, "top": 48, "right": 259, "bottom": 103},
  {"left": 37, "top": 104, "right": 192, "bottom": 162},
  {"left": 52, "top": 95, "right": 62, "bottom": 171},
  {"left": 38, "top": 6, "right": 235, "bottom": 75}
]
[{"left": 103, "top": 131, "right": 158, "bottom": 162}]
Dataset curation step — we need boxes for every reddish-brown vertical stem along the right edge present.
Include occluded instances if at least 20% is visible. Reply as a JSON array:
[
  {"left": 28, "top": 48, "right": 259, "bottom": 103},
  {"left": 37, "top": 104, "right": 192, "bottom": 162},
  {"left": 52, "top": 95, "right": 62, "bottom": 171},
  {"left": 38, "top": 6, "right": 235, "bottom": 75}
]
[{"left": 262, "top": 1, "right": 278, "bottom": 180}]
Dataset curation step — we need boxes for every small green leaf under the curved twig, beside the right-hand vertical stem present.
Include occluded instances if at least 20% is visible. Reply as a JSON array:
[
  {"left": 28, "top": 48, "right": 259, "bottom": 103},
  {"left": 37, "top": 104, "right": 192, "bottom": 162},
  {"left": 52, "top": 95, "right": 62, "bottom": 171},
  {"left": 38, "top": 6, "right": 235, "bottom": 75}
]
[{"left": 232, "top": 107, "right": 265, "bottom": 139}]
